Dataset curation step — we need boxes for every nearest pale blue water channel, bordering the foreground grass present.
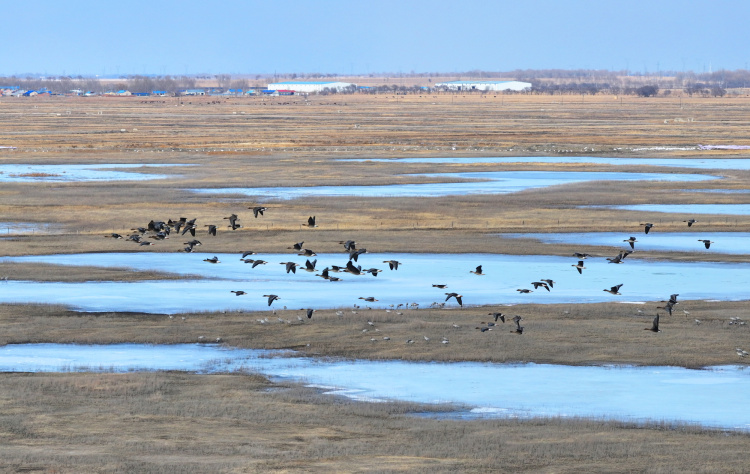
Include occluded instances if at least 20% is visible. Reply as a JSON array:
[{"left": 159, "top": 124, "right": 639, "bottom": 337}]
[{"left": 0, "top": 342, "right": 750, "bottom": 430}]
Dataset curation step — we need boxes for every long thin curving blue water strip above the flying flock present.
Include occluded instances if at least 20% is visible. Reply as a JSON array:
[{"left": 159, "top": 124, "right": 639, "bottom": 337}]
[{"left": 190, "top": 171, "right": 718, "bottom": 200}]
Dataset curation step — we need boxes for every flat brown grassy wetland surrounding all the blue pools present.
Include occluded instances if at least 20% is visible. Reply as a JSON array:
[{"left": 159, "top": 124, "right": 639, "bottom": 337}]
[{"left": 0, "top": 94, "right": 750, "bottom": 472}]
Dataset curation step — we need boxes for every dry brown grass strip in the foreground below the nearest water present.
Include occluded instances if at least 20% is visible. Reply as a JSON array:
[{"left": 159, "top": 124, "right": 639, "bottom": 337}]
[{"left": 0, "top": 373, "right": 750, "bottom": 472}]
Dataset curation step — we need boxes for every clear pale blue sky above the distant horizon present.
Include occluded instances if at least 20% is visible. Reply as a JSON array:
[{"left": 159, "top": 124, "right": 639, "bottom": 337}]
[{"left": 0, "top": 0, "right": 750, "bottom": 76}]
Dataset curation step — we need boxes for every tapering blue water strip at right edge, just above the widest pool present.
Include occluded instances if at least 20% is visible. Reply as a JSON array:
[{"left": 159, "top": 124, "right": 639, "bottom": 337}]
[{"left": 506, "top": 233, "right": 750, "bottom": 257}]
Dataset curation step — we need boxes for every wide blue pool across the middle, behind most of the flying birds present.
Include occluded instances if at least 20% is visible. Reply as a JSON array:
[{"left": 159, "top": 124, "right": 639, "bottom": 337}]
[{"left": 0, "top": 254, "right": 750, "bottom": 312}]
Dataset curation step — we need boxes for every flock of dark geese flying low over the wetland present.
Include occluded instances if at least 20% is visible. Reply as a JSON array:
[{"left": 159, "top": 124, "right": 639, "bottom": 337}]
[{"left": 105, "top": 206, "right": 736, "bottom": 336}]
